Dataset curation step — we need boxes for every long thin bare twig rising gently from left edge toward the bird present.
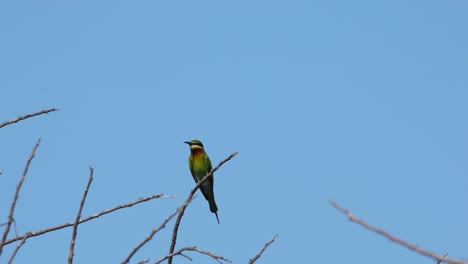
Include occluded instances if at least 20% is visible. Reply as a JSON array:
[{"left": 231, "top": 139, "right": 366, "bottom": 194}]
[{"left": 4, "top": 194, "right": 176, "bottom": 245}]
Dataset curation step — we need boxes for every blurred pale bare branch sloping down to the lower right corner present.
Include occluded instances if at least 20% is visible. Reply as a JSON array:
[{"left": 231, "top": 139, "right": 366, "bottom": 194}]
[{"left": 328, "top": 200, "right": 468, "bottom": 264}]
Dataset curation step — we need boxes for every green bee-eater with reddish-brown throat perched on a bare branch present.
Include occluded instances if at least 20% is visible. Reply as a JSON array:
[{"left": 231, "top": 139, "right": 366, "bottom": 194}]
[{"left": 184, "top": 139, "right": 219, "bottom": 224}]
